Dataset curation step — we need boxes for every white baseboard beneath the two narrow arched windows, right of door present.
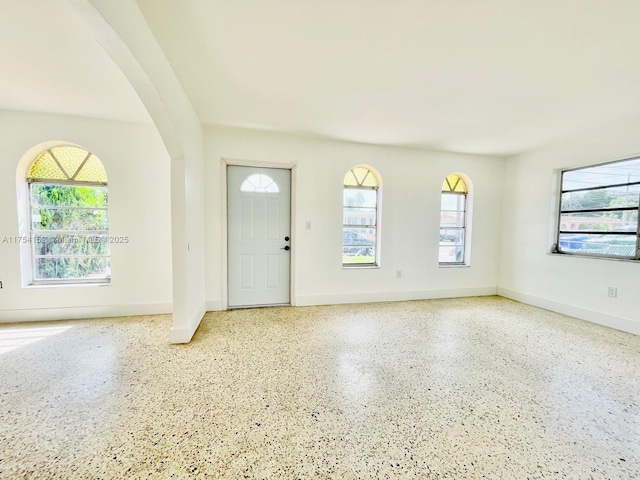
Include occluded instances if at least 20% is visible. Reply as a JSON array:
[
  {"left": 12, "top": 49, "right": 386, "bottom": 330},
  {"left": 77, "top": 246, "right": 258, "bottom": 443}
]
[{"left": 295, "top": 287, "right": 497, "bottom": 307}]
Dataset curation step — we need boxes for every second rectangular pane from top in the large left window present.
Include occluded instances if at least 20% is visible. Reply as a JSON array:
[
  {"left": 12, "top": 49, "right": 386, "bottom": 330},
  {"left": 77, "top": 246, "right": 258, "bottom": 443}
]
[{"left": 31, "top": 208, "right": 109, "bottom": 231}]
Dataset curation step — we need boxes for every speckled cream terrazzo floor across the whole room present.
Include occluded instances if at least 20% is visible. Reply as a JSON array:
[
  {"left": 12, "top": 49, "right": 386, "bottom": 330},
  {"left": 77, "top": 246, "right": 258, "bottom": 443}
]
[{"left": 0, "top": 297, "right": 640, "bottom": 480}]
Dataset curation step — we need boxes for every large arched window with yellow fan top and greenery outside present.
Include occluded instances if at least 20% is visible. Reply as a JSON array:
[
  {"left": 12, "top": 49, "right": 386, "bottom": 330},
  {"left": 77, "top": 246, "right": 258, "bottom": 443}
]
[{"left": 26, "top": 145, "right": 111, "bottom": 284}]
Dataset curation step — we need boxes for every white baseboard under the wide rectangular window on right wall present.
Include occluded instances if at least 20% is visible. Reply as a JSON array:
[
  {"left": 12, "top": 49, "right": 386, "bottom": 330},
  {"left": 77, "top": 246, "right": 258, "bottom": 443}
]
[{"left": 498, "top": 287, "right": 640, "bottom": 335}]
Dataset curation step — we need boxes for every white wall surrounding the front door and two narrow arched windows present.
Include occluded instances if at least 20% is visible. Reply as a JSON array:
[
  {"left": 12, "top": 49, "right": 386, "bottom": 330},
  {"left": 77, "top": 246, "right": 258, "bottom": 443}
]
[{"left": 205, "top": 128, "right": 503, "bottom": 310}]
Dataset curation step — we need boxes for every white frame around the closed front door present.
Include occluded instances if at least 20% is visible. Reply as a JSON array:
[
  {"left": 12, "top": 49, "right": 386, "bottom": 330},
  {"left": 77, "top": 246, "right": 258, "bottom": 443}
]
[{"left": 220, "top": 157, "right": 297, "bottom": 310}]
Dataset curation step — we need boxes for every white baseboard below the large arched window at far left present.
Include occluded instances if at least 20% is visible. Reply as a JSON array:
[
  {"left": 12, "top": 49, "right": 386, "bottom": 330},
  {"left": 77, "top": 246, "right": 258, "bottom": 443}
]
[{"left": 0, "top": 303, "right": 172, "bottom": 323}]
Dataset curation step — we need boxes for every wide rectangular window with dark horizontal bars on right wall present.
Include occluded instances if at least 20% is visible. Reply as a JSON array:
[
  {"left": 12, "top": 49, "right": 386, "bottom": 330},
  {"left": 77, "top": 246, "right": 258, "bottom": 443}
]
[{"left": 556, "top": 158, "right": 640, "bottom": 260}]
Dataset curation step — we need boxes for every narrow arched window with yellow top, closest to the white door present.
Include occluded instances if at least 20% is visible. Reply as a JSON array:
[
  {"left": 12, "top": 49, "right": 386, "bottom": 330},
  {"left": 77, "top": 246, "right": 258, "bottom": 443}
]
[{"left": 342, "top": 166, "right": 380, "bottom": 267}]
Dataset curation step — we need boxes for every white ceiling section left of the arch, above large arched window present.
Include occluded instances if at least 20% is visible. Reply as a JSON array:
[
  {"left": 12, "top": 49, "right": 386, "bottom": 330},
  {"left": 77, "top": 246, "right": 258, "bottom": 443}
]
[{"left": 0, "top": 0, "right": 151, "bottom": 123}]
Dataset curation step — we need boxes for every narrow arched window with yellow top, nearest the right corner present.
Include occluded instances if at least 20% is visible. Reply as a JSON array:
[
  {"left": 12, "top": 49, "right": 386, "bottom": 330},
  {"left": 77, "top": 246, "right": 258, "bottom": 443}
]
[{"left": 438, "top": 174, "right": 468, "bottom": 265}]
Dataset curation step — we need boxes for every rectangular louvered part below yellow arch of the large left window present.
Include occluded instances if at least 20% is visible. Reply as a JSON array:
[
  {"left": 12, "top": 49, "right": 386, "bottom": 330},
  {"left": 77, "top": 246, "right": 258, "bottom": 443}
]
[{"left": 29, "top": 182, "right": 111, "bottom": 284}]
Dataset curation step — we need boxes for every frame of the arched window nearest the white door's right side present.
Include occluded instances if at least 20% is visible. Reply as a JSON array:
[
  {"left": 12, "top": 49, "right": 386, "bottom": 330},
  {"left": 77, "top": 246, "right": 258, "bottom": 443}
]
[{"left": 342, "top": 165, "right": 382, "bottom": 269}]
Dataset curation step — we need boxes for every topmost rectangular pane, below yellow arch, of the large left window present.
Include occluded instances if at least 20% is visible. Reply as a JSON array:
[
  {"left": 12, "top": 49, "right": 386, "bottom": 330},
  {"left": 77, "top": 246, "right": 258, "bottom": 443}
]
[{"left": 31, "top": 183, "right": 108, "bottom": 208}]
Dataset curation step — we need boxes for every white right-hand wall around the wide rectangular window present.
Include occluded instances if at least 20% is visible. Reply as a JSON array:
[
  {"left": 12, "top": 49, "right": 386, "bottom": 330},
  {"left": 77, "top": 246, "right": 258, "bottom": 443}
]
[{"left": 499, "top": 119, "right": 640, "bottom": 333}]
